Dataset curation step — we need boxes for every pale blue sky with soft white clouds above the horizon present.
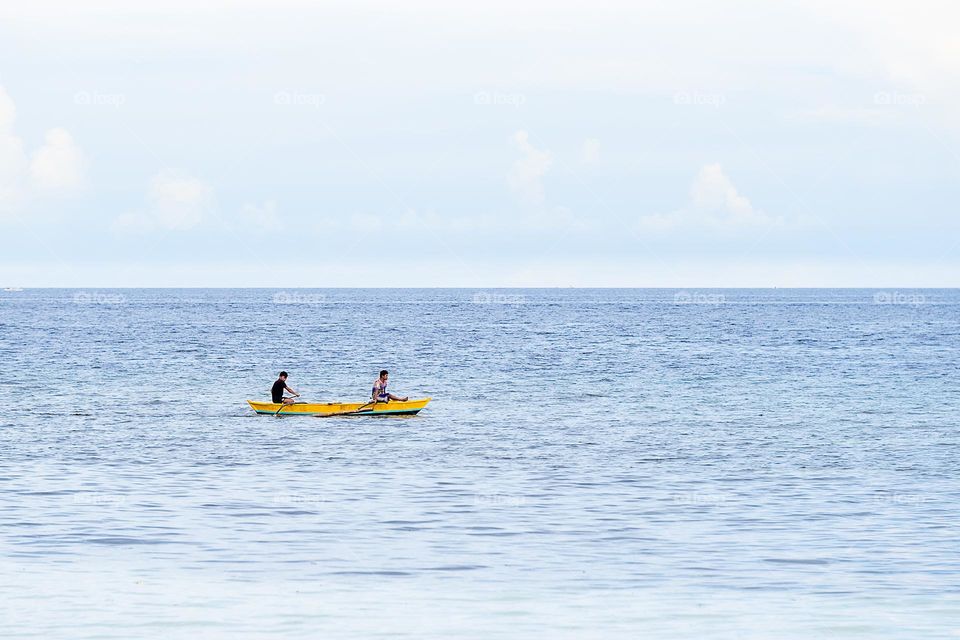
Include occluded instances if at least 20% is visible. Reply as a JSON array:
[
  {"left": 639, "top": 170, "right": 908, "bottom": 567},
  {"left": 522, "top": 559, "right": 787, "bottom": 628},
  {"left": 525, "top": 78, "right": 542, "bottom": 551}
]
[{"left": 0, "top": 0, "right": 960, "bottom": 287}]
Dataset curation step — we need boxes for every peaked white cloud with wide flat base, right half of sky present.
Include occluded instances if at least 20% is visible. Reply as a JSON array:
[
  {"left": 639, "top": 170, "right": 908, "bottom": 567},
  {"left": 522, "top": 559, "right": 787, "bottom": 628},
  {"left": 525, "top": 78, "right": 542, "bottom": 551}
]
[{"left": 640, "top": 163, "right": 783, "bottom": 231}]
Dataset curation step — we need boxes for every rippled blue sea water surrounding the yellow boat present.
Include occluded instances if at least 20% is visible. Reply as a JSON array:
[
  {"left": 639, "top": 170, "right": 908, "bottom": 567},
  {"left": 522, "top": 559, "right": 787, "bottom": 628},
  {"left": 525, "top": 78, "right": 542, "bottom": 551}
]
[{"left": 0, "top": 289, "right": 960, "bottom": 638}]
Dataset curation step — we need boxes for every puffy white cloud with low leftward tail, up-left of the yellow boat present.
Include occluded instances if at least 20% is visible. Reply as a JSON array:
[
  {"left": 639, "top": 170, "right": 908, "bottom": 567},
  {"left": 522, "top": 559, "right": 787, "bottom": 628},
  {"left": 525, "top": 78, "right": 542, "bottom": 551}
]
[{"left": 113, "top": 169, "right": 213, "bottom": 233}]
